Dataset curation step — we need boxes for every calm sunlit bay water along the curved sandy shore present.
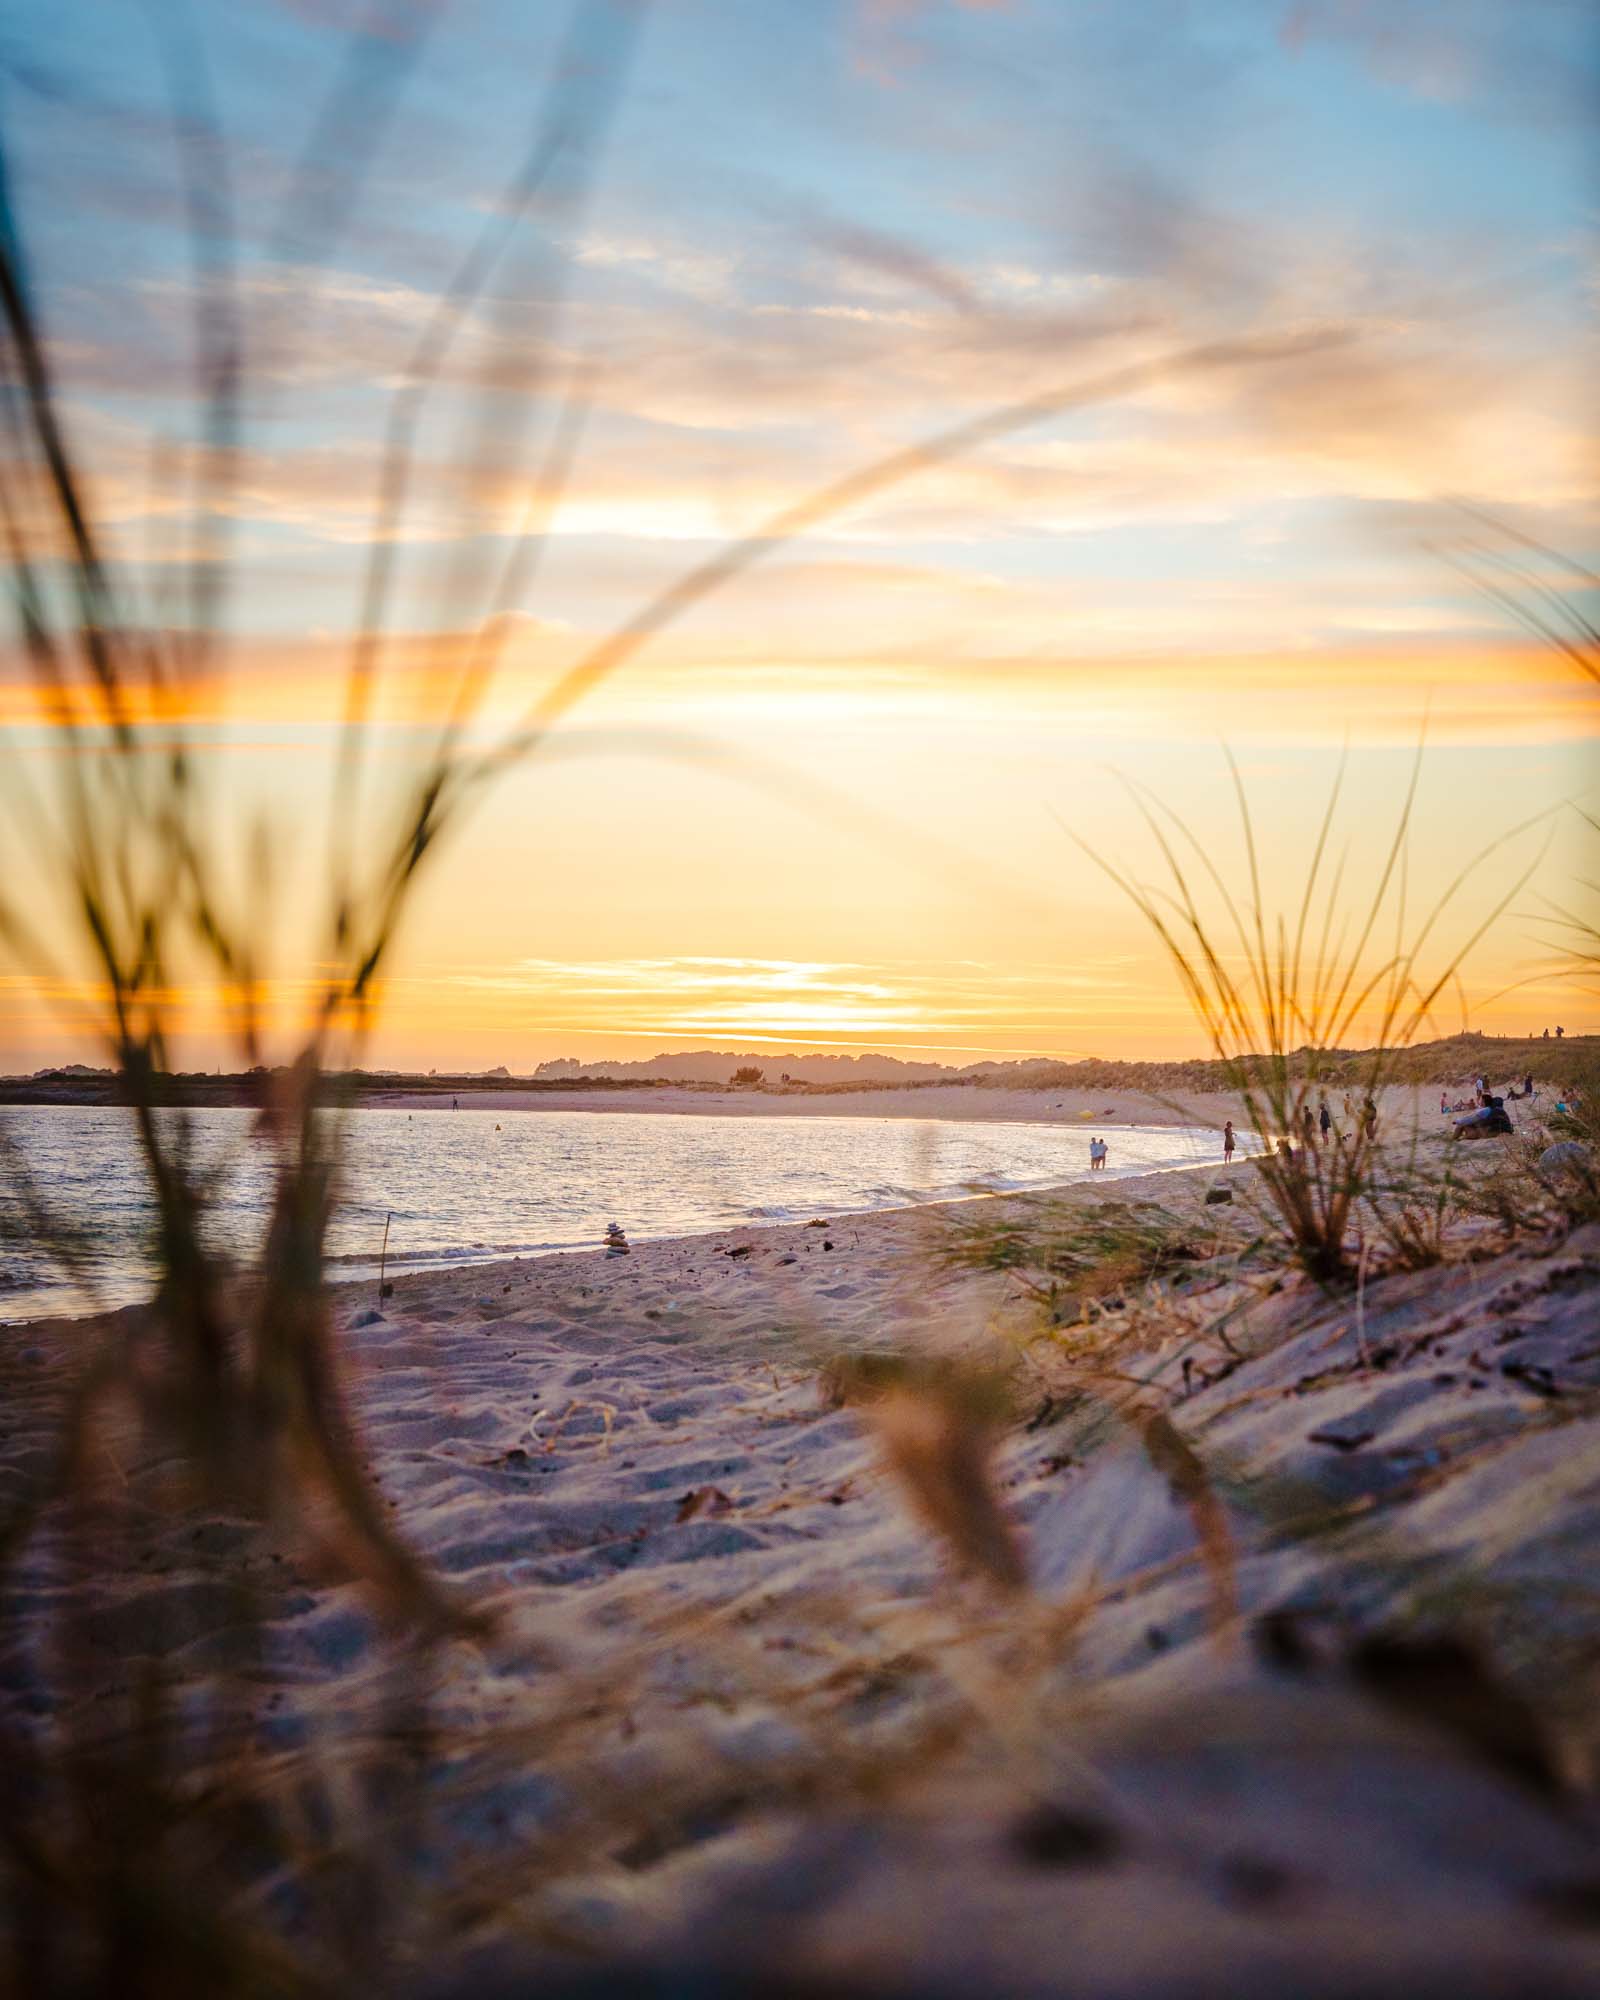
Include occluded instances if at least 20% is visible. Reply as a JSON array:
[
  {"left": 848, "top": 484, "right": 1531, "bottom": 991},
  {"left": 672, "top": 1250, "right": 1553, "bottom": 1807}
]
[{"left": 0, "top": 1108, "right": 1218, "bottom": 1320}]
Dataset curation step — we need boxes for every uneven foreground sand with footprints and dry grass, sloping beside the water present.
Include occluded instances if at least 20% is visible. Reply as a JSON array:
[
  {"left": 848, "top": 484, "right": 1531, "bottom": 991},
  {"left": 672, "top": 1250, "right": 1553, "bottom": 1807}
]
[{"left": 0, "top": 1136, "right": 1600, "bottom": 1996}]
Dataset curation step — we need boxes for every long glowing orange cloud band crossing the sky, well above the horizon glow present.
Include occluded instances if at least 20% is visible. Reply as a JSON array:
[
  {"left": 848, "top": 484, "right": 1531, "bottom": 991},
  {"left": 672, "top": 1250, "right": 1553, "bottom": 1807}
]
[{"left": 0, "top": 628, "right": 1600, "bottom": 744}]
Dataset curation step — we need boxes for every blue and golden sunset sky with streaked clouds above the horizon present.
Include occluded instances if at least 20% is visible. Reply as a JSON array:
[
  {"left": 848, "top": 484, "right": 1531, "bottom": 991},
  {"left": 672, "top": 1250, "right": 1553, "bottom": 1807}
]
[{"left": 0, "top": 0, "right": 1600, "bottom": 1070}]
